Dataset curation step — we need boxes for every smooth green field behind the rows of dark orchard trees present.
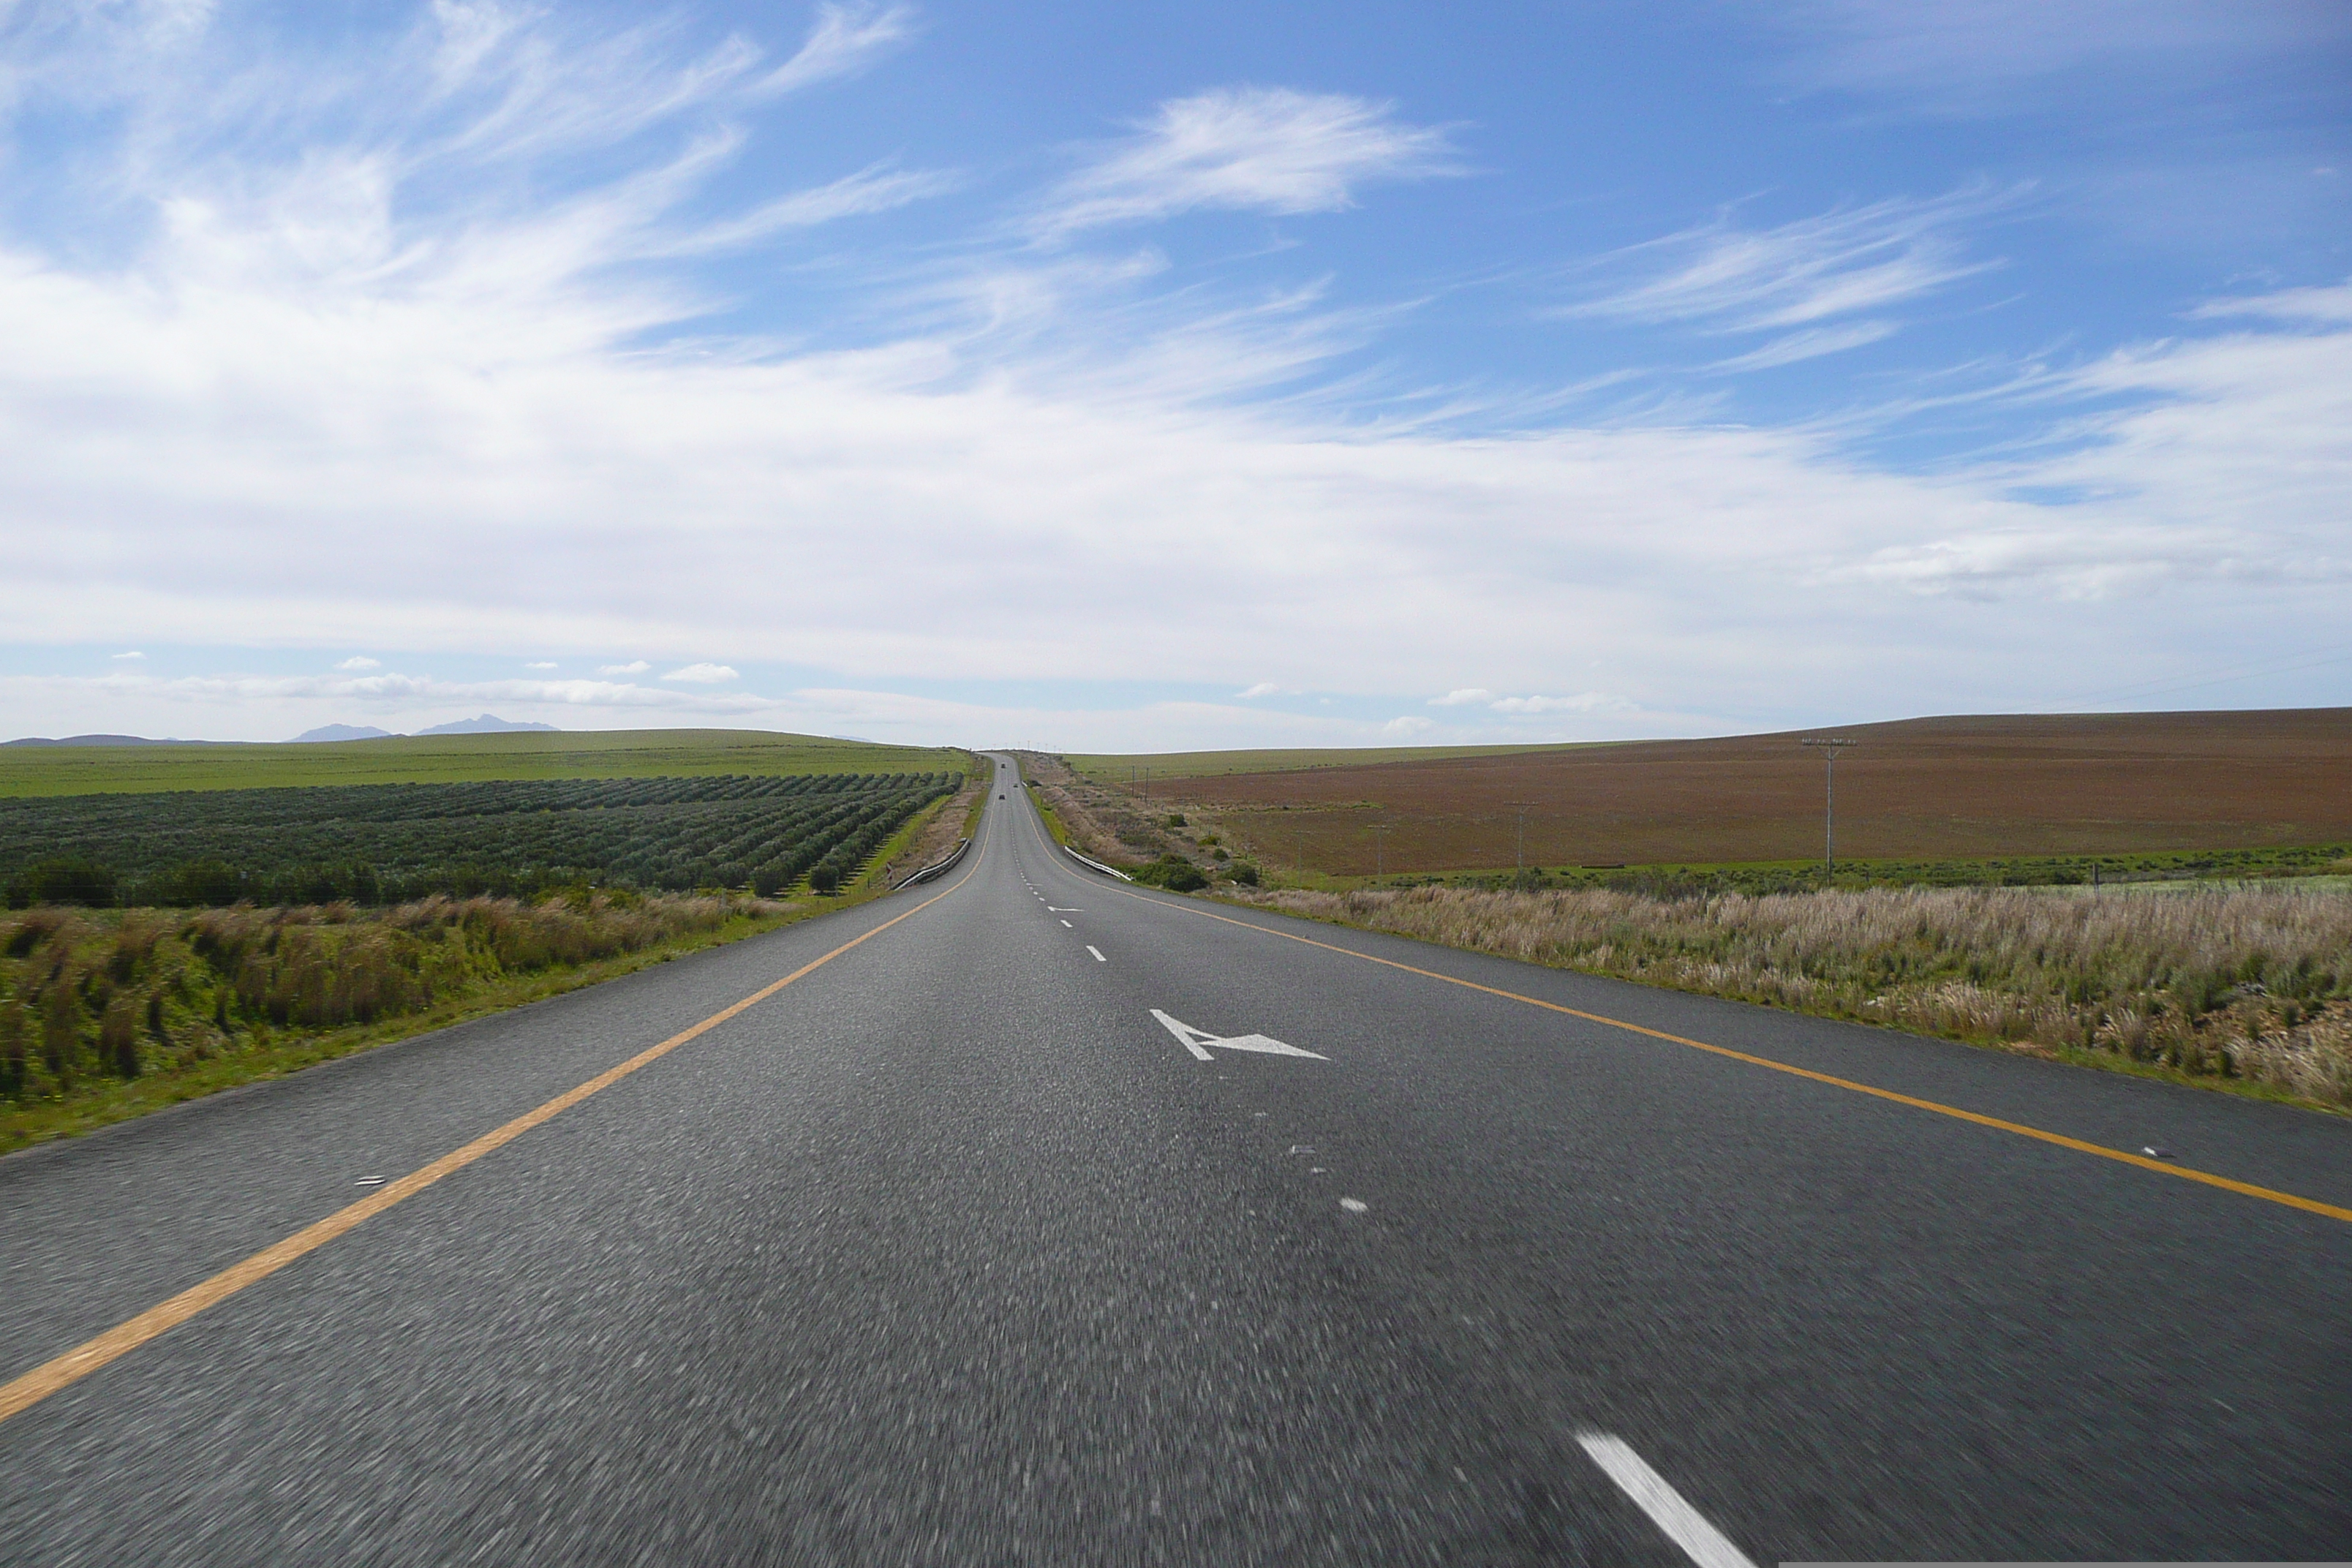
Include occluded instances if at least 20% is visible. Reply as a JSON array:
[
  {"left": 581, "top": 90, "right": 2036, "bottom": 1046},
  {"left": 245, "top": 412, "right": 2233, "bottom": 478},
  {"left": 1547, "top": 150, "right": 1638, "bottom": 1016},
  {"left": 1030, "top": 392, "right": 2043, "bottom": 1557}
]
[{"left": 0, "top": 728, "right": 976, "bottom": 799}]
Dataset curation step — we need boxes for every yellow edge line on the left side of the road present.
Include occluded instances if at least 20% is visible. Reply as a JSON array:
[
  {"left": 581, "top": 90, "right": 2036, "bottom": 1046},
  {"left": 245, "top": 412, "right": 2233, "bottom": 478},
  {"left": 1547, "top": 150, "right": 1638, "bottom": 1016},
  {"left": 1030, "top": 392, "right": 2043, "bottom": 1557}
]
[{"left": 0, "top": 827, "right": 986, "bottom": 1420}]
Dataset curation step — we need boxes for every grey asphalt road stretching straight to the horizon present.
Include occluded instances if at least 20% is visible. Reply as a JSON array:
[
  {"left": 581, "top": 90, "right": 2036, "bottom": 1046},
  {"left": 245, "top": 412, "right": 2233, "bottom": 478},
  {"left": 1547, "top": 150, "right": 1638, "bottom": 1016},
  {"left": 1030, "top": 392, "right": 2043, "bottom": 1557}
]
[{"left": 0, "top": 752, "right": 2352, "bottom": 1568}]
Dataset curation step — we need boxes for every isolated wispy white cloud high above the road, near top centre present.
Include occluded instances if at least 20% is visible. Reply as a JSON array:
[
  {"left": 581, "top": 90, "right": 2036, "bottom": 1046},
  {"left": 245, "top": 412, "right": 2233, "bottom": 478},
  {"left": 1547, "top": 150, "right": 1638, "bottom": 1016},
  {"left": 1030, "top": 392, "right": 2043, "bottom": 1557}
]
[{"left": 1037, "top": 87, "right": 1451, "bottom": 235}]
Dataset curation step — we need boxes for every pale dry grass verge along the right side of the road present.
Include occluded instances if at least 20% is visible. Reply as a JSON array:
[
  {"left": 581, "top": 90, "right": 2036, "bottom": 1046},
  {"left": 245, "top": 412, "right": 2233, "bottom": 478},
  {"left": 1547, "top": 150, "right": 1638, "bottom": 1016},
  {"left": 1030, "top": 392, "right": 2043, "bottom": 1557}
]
[{"left": 1249, "top": 884, "right": 2352, "bottom": 1107}]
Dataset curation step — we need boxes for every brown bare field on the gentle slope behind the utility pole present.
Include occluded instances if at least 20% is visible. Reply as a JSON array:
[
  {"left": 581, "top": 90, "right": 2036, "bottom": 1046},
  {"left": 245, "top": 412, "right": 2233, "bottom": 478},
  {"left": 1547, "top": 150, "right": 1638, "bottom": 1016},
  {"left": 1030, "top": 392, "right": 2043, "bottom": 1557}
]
[{"left": 1153, "top": 708, "right": 2352, "bottom": 877}]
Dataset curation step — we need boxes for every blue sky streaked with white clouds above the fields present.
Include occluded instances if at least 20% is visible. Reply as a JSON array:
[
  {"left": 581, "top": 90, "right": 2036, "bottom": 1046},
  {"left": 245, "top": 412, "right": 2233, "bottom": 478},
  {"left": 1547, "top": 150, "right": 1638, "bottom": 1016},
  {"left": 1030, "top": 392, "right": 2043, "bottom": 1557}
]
[{"left": 0, "top": 0, "right": 2352, "bottom": 750}]
